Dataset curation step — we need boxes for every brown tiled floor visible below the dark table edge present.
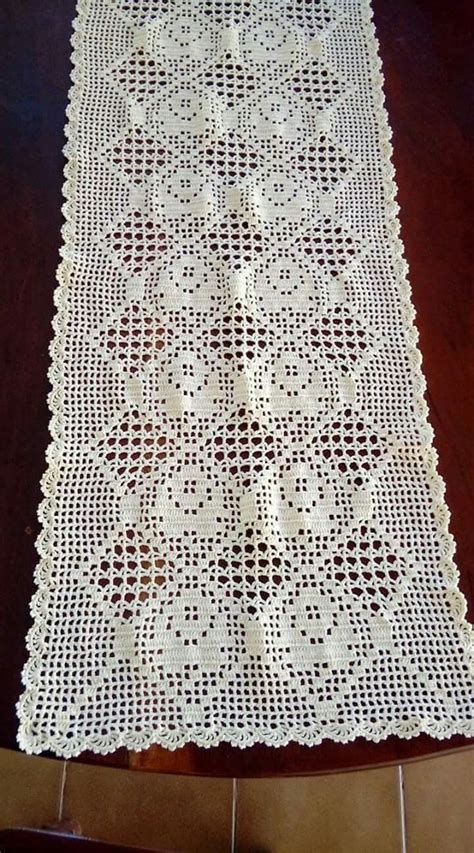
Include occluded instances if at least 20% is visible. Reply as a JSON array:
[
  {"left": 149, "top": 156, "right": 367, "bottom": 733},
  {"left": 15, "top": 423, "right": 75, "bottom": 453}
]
[{"left": 0, "top": 750, "right": 474, "bottom": 853}]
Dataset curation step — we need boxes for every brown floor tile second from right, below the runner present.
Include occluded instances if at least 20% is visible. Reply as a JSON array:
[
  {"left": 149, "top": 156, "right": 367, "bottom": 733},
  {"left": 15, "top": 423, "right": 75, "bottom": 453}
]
[{"left": 237, "top": 767, "right": 400, "bottom": 853}]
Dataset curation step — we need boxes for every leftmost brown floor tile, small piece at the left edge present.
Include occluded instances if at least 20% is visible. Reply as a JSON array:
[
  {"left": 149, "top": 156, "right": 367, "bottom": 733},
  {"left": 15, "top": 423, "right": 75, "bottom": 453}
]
[{"left": 0, "top": 749, "right": 63, "bottom": 828}]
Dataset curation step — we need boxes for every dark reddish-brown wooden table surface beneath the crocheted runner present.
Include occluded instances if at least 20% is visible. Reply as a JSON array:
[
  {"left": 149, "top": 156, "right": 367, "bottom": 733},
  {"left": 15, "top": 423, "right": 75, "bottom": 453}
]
[{"left": 0, "top": 0, "right": 474, "bottom": 776}]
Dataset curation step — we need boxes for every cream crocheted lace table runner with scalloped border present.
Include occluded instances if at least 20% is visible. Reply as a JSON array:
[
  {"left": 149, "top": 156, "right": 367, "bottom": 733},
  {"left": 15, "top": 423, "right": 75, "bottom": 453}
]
[{"left": 19, "top": 0, "right": 472, "bottom": 756}]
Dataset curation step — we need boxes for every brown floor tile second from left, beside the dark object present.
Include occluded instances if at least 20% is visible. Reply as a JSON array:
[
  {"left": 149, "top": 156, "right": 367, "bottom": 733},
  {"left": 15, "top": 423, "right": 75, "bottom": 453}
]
[{"left": 64, "top": 763, "right": 232, "bottom": 853}]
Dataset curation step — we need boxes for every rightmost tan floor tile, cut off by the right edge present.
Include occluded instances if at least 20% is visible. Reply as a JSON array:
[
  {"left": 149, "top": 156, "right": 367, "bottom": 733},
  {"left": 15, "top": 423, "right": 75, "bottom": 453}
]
[{"left": 403, "top": 749, "right": 474, "bottom": 853}]
